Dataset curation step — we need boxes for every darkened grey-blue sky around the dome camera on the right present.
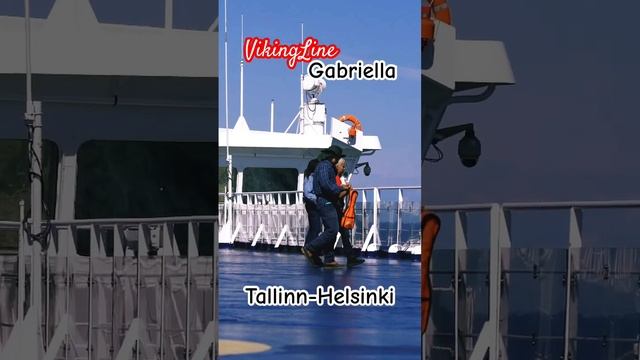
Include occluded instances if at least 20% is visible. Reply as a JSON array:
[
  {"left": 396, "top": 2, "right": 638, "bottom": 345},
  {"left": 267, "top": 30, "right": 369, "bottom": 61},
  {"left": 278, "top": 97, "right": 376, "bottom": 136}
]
[{"left": 422, "top": 0, "right": 640, "bottom": 247}]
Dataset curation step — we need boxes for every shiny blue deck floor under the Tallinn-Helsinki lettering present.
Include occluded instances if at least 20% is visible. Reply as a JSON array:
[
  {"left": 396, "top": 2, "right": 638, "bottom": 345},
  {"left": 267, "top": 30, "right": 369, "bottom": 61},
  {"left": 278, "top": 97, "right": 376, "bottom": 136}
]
[{"left": 219, "top": 249, "right": 420, "bottom": 360}]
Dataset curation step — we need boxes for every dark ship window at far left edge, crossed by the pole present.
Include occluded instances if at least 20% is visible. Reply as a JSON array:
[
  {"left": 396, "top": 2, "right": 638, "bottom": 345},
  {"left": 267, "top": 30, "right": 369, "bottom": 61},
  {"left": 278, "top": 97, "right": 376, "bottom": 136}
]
[{"left": 0, "top": 140, "right": 59, "bottom": 249}]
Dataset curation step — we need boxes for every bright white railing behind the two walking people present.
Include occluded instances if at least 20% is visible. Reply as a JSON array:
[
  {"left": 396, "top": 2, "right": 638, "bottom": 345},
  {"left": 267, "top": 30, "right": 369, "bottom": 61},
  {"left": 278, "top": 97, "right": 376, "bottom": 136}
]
[{"left": 219, "top": 186, "right": 420, "bottom": 255}]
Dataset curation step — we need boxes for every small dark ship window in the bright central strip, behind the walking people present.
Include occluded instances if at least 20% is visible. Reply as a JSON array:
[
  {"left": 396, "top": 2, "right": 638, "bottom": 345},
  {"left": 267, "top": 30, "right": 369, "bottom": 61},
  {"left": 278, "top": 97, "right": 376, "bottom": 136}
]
[{"left": 242, "top": 168, "right": 298, "bottom": 192}]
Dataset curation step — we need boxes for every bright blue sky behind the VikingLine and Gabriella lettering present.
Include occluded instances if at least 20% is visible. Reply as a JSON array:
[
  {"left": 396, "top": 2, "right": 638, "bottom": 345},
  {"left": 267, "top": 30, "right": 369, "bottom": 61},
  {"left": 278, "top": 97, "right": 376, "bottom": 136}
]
[{"left": 219, "top": 0, "right": 420, "bottom": 186}]
